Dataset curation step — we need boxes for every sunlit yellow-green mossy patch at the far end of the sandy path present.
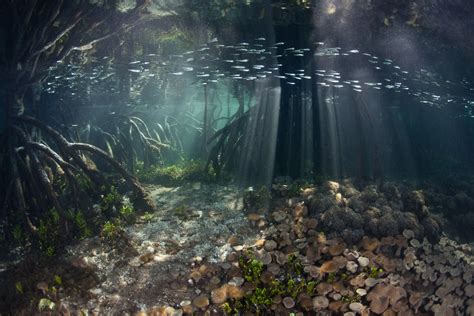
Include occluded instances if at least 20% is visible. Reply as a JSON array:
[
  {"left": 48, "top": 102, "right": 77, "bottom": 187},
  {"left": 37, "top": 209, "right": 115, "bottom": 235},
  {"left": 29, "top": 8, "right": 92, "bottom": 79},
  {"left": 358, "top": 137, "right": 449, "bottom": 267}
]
[{"left": 136, "top": 160, "right": 220, "bottom": 186}]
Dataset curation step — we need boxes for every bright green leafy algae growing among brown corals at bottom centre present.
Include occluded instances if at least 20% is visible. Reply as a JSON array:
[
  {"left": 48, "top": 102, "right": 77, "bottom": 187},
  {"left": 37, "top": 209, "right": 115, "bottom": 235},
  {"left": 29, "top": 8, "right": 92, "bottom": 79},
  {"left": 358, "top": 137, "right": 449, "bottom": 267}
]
[{"left": 221, "top": 251, "right": 320, "bottom": 315}]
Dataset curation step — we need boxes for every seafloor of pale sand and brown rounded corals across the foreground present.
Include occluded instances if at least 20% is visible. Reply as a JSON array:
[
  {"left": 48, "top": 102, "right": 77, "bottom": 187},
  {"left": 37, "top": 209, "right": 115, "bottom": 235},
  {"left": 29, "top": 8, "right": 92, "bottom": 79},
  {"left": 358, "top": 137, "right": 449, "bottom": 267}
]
[{"left": 0, "top": 180, "right": 474, "bottom": 316}]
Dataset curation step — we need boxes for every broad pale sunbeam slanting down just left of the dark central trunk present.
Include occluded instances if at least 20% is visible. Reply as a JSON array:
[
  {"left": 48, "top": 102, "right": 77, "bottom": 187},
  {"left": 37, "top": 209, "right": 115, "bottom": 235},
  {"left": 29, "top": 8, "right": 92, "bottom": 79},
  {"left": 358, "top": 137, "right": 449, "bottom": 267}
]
[{"left": 238, "top": 79, "right": 281, "bottom": 185}]
